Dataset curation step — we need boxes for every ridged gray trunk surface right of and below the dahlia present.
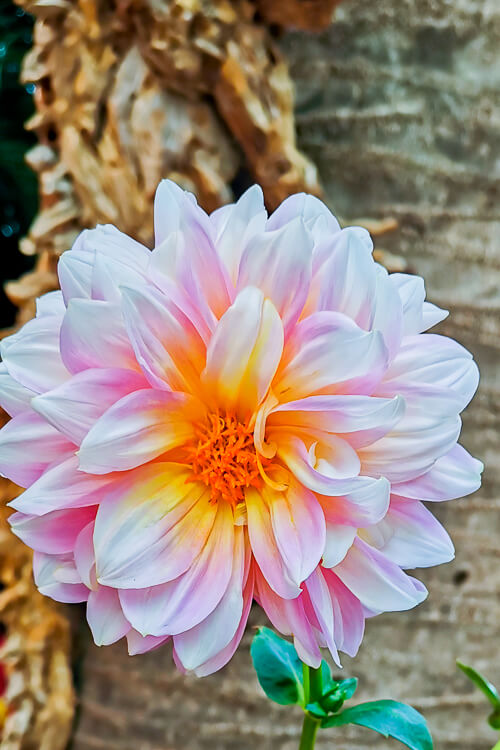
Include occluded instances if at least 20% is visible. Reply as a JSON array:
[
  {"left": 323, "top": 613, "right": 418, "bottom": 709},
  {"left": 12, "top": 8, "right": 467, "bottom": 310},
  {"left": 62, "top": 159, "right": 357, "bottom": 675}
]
[{"left": 72, "top": 0, "right": 500, "bottom": 750}]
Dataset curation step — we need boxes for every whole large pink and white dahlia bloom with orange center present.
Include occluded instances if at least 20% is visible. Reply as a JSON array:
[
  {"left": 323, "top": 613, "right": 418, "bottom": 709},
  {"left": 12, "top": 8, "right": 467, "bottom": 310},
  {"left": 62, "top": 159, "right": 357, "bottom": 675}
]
[{"left": 0, "top": 181, "right": 482, "bottom": 675}]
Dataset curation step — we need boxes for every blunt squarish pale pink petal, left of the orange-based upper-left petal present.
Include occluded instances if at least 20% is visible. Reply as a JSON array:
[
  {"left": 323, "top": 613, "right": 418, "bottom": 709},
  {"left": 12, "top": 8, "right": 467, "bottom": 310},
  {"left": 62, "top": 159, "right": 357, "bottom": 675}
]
[{"left": 61, "top": 299, "right": 139, "bottom": 374}]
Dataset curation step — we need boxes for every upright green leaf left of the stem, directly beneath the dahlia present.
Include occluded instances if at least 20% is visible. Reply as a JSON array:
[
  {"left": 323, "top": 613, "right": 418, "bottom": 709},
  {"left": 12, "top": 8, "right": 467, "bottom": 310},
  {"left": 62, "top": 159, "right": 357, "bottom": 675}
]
[{"left": 250, "top": 628, "right": 304, "bottom": 706}]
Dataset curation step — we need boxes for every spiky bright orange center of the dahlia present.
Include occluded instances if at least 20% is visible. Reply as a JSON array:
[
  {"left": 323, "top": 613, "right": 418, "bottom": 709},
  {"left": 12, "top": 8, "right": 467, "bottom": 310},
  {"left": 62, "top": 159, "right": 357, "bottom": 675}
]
[{"left": 187, "top": 413, "right": 268, "bottom": 507}]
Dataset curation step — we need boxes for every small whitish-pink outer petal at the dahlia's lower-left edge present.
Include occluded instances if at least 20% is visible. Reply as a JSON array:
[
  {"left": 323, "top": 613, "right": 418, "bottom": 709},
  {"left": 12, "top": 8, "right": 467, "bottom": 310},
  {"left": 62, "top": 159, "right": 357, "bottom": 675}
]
[{"left": 33, "top": 552, "right": 89, "bottom": 604}]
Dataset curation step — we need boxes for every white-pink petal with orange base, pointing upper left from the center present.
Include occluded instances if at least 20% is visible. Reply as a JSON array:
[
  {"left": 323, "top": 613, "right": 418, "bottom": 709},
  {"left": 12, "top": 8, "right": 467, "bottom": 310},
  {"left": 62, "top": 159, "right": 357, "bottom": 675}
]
[{"left": 122, "top": 287, "right": 206, "bottom": 392}]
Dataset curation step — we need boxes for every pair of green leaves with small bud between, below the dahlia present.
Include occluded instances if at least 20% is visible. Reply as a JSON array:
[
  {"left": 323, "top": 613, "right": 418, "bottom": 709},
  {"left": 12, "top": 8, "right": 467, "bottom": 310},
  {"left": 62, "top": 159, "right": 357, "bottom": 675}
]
[{"left": 251, "top": 628, "right": 433, "bottom": 750}]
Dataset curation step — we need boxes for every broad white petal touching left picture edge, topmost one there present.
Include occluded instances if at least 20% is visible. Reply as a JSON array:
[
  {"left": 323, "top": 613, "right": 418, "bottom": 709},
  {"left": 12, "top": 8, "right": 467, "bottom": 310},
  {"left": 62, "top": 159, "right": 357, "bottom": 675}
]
[{"left": 0, "top": 315, "right": 69, "bottom": 393}]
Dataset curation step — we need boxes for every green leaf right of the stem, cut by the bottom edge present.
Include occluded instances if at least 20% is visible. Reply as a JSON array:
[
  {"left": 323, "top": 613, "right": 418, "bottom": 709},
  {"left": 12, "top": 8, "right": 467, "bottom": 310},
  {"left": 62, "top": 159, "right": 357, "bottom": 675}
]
[{"left": 321, "top": 701, "right": 433, "bottom": 750}]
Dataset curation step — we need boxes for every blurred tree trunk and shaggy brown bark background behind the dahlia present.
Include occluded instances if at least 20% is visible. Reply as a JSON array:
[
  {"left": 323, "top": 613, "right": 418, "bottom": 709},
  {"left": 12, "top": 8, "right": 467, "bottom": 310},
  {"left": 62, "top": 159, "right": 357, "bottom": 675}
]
[{"left": 0, "top": 0, "right": 500, "bottom": 750}]
